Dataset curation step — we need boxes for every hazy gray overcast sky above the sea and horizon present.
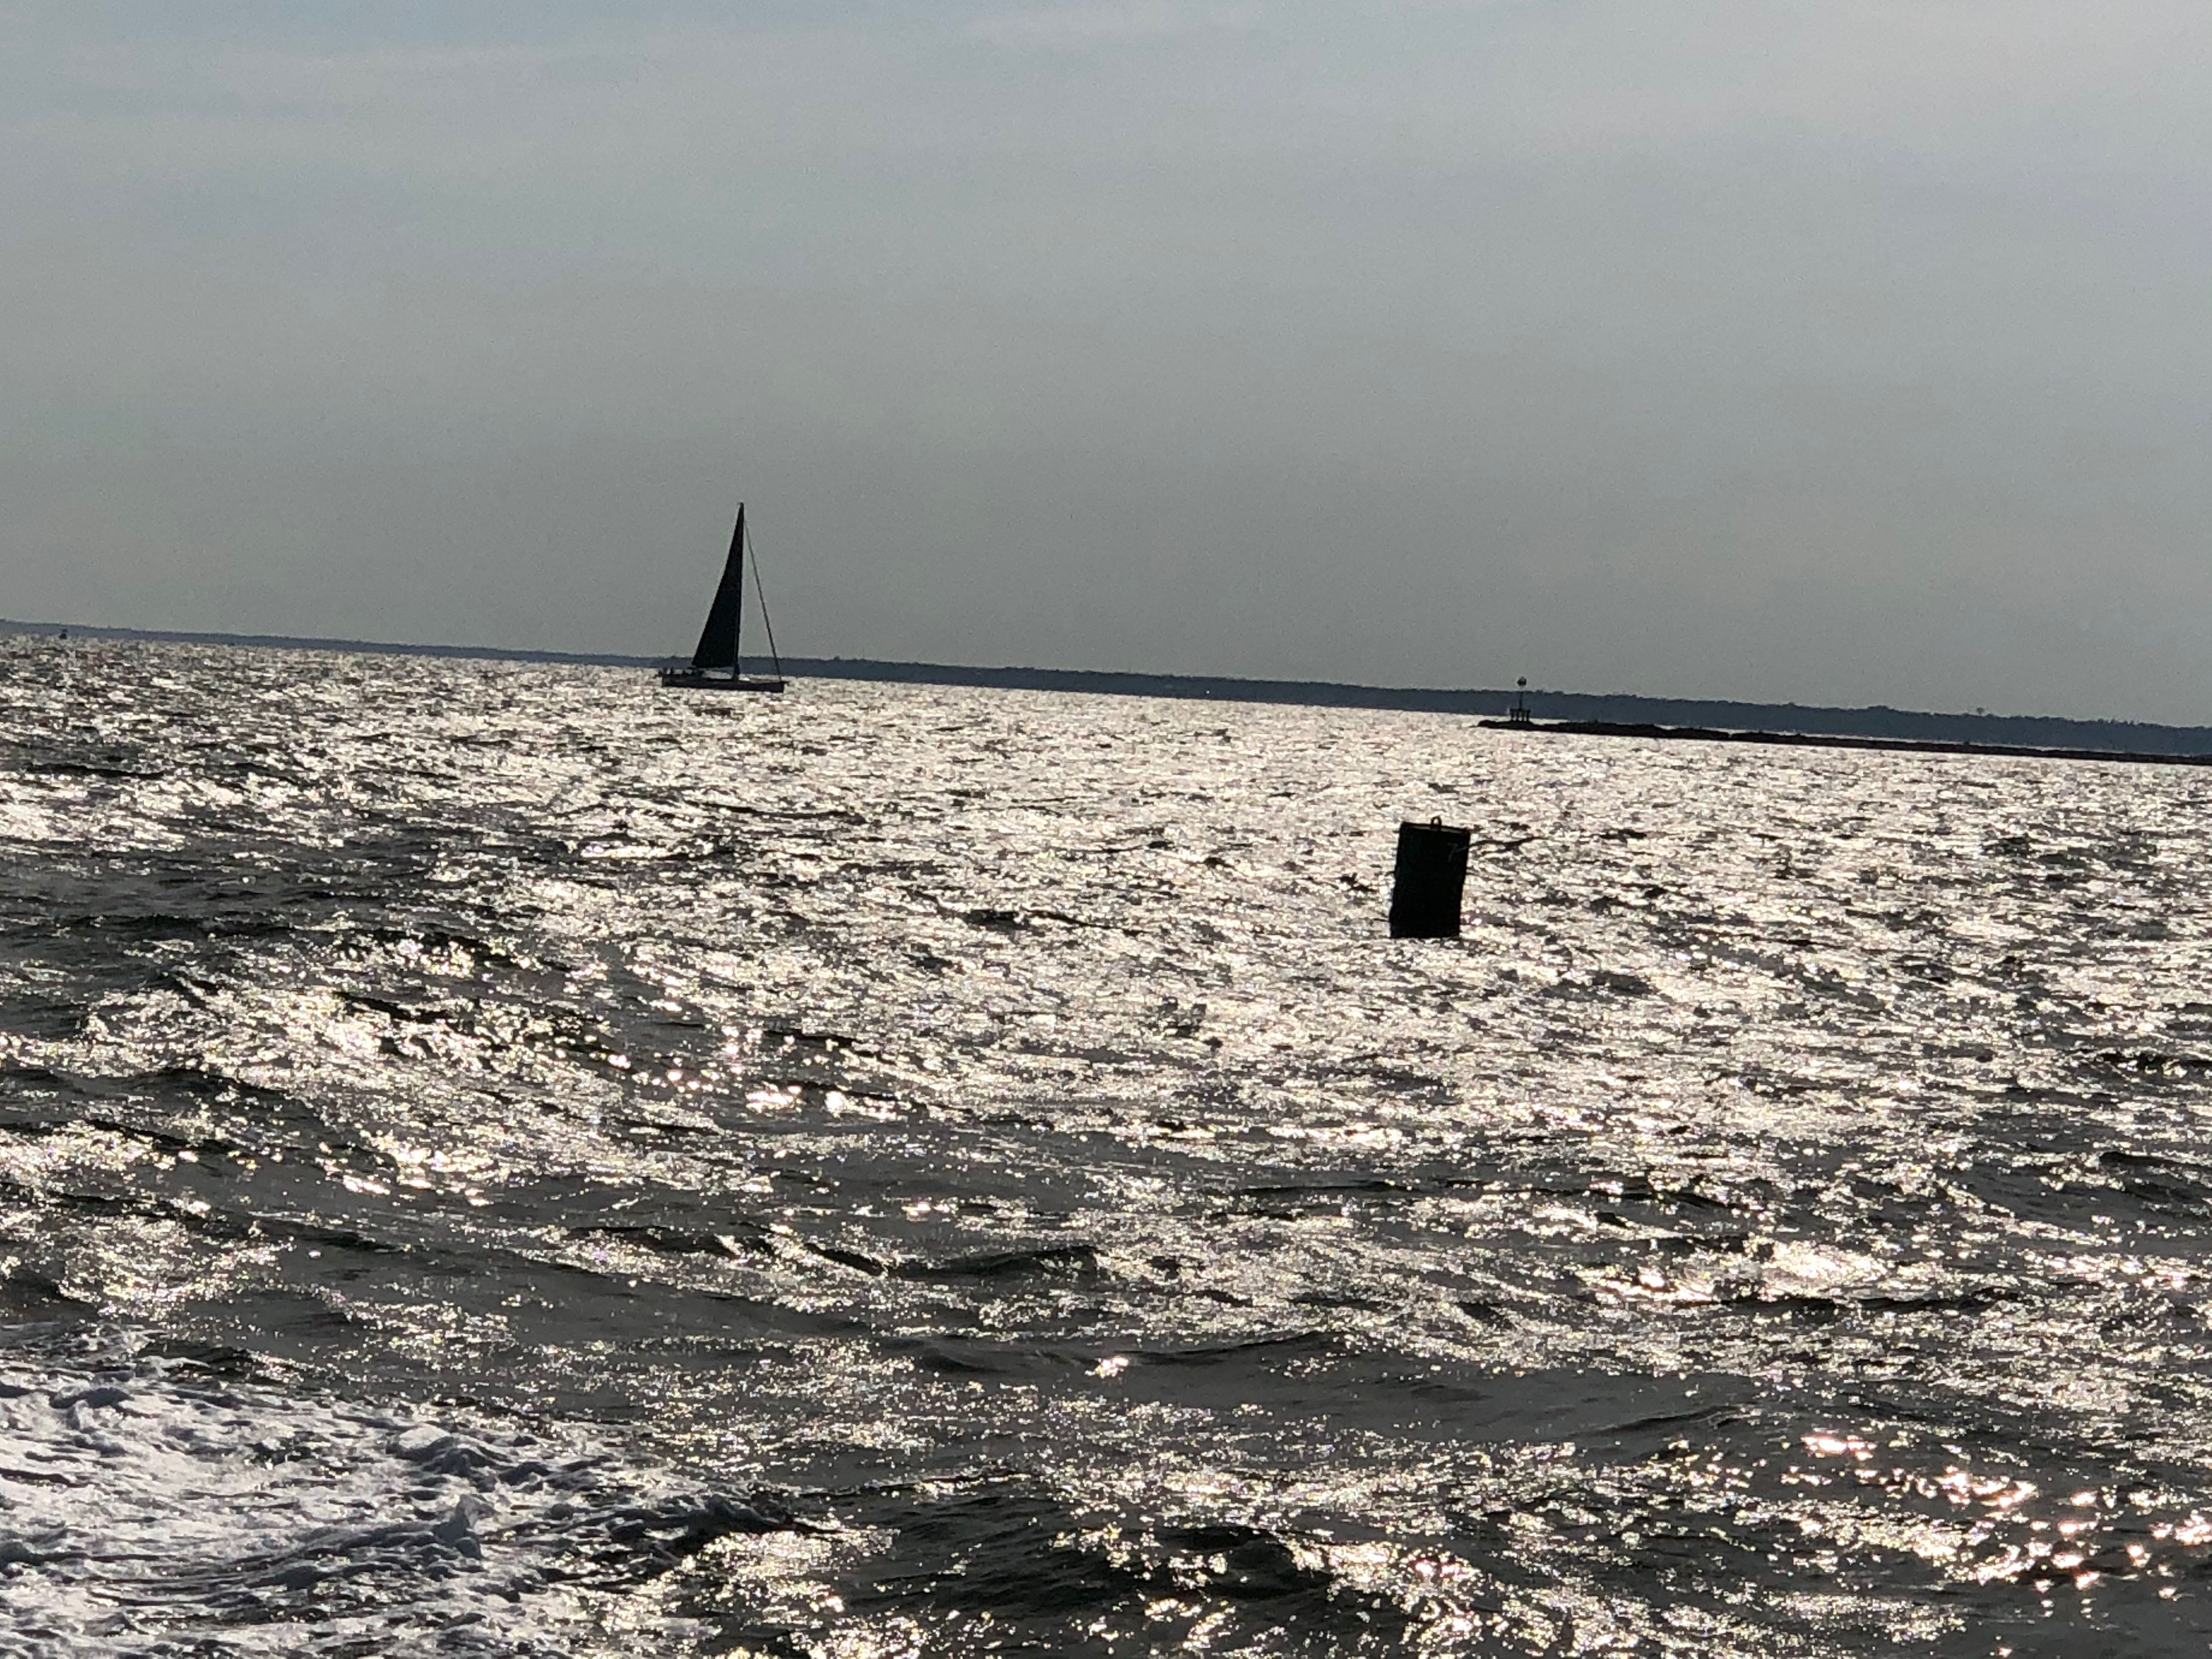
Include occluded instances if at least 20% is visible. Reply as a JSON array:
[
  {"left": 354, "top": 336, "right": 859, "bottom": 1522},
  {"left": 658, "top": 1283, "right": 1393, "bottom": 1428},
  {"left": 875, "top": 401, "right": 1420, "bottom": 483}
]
[{"left": 0, "top": 0, "right": 2212, "bottom": 723}]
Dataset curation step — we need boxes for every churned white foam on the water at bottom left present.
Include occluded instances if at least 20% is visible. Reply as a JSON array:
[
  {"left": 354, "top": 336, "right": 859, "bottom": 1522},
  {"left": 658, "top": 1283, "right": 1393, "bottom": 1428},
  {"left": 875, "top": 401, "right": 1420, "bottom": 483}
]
[{"left": 0, "top": 1338, "right": 750, "bottom": 1659}]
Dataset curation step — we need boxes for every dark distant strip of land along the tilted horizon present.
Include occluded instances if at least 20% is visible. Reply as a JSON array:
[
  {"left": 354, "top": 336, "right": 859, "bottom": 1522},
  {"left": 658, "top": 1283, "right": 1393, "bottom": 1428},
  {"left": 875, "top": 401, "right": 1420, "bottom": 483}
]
[{"left": 0, "top": 617, "right": 2212, "bottom": 754}]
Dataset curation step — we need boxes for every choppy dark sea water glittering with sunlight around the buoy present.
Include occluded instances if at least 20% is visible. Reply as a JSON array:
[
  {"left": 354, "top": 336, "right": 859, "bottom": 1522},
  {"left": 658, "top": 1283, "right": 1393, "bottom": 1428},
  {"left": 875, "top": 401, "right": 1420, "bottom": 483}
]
[{"left": 0, "top": 639, "right": 2212, "bottom": 1659}]
